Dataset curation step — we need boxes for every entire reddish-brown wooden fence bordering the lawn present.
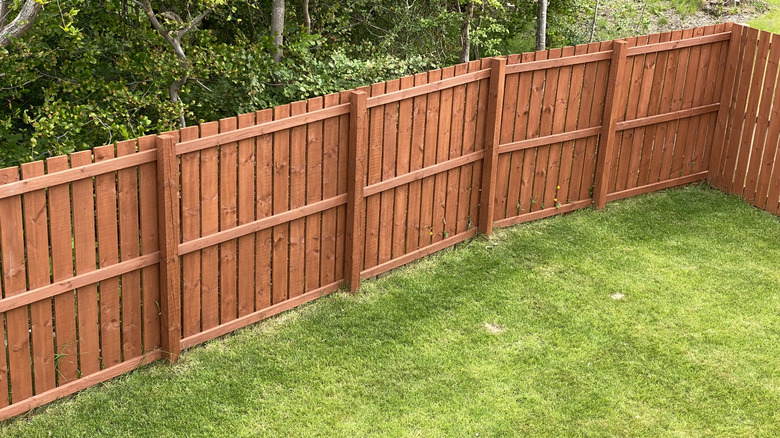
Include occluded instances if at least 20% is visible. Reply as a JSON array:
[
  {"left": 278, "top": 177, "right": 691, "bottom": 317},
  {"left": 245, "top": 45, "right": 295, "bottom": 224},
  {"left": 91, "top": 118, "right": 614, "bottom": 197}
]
[{"left": 0, "top": 24, "right": 780, "bottom": 418}]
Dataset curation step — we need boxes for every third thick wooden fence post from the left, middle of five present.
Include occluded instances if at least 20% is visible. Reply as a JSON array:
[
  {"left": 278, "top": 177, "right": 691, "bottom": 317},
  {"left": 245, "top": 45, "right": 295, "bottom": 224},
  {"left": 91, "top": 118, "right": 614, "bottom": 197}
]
[{"left": 479, "top": 57, "right": 506, "bottom": 235}]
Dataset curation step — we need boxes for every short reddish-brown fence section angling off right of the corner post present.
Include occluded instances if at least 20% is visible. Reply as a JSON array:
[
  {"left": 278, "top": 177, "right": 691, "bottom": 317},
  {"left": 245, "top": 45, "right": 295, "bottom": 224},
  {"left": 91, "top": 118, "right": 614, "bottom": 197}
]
[{"left": 709, "top": 26, "right": 780, "bottom": 214}]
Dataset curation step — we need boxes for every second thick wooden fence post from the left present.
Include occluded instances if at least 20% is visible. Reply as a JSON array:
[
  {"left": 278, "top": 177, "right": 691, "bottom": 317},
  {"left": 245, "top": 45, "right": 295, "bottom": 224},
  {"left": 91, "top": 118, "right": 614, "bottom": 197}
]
[{"left": 344, "top": 91, "right": 368, "bottom": 292}]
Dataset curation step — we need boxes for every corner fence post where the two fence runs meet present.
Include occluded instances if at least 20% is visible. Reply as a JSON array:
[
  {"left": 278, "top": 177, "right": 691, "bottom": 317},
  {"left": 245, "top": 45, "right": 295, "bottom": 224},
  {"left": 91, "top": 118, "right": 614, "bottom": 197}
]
[{"left": 704, "top": 23, "right": 744, "bottom": 188}]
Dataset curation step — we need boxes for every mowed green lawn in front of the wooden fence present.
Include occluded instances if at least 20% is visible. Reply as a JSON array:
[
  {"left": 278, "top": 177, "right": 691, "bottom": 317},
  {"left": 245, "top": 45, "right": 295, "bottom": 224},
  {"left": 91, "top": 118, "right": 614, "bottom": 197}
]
[{"left": 0, "top": 186, "right": 780, "bottom": 437}]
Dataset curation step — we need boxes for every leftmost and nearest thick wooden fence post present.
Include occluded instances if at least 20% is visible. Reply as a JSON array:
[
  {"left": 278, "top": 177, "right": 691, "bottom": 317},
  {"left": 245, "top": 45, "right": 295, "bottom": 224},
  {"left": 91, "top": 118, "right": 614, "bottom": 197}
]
[{"left": 157, "top": 135, "right": 181, "bottom": 363}]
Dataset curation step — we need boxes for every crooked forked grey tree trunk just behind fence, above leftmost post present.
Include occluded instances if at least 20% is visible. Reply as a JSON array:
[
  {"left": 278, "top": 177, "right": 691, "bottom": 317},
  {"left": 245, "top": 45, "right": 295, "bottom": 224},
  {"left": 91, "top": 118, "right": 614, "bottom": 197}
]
[{"left": 132, "top": 0, "right": 217, "bottom": 128}]
